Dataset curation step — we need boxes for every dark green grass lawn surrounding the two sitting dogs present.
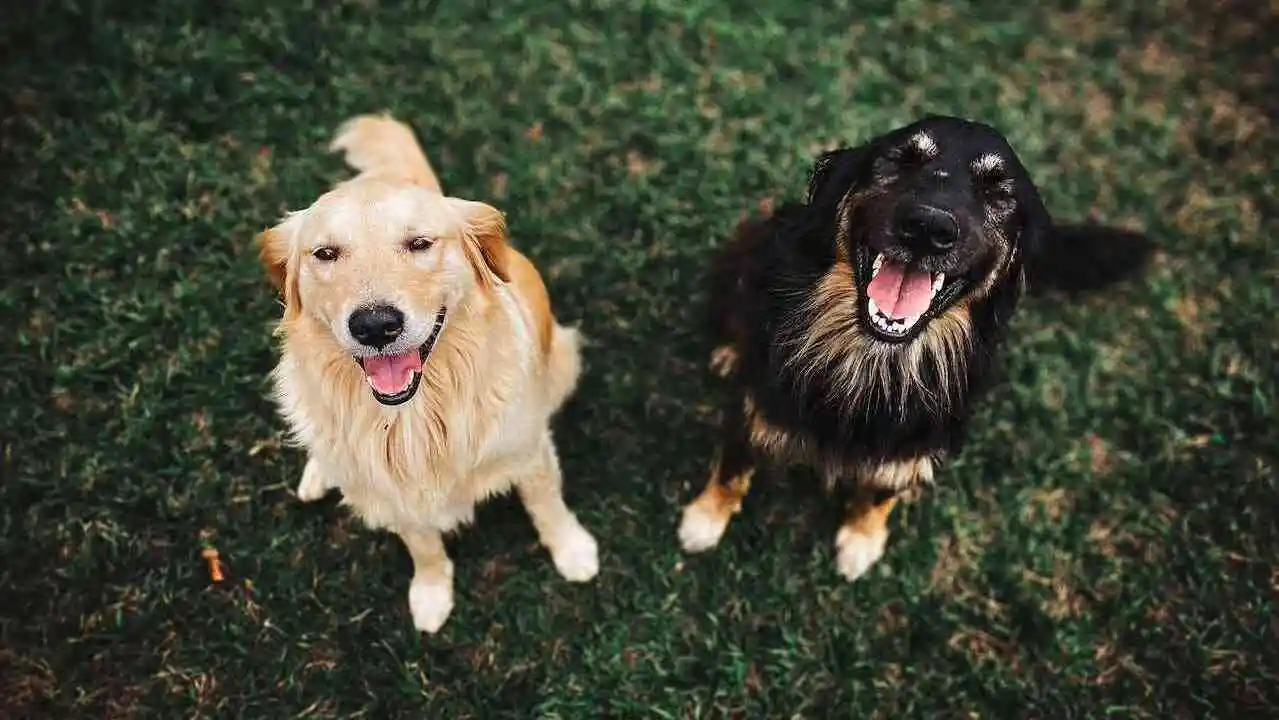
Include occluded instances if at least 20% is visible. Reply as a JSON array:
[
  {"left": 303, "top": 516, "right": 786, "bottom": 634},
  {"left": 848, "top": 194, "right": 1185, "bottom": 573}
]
[{"left": 0, "top": 0, "right": 1279, "bottom": 719}]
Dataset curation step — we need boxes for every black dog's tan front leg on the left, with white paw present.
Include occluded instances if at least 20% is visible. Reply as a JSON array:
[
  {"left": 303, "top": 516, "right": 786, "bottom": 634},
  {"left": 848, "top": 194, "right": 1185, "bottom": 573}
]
[{"left": 679, "top": 409, "right": 755, "bottom": 552}]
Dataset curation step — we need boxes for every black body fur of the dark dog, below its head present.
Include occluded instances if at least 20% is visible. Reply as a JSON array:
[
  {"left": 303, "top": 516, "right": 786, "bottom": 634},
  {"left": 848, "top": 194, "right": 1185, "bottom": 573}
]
[{"left": 709, "top": 207, "right": 1017, "bottom": 474}]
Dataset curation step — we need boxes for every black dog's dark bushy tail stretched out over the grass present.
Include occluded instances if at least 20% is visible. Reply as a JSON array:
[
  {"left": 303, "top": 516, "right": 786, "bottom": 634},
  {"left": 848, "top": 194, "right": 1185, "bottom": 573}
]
[{"left": 1026, "top": 224, "right": 1154, "bottom": 295}]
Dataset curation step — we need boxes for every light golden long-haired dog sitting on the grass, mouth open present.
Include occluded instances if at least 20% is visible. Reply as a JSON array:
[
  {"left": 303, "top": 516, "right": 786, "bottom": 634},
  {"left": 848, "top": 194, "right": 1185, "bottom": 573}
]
[{"left": 257, "top": 115, "right": 599, "bottom": 633}]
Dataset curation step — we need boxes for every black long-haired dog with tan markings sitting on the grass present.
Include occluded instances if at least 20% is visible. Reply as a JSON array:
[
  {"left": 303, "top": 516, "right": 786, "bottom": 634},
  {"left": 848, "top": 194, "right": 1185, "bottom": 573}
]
[{"left": 678, "top": 115, "right": 1150, "bottom": 581}]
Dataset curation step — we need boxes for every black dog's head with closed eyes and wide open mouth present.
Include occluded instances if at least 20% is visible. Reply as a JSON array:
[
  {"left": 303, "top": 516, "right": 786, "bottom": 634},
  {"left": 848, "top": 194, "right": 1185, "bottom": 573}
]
[{"left": 808, "top": 115, "right": 1051, "bottom": 343}]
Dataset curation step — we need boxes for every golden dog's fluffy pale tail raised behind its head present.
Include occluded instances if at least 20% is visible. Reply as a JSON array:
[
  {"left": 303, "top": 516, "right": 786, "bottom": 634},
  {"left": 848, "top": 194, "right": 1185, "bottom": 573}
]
[{"left": 329, "top": 115, "right": 444, "bottom": 193}]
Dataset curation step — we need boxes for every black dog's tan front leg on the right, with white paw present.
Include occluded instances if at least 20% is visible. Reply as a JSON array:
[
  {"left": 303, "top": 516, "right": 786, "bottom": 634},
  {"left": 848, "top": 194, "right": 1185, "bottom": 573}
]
[{"left": 835, "top": 458, "right": 932, "bottom": 581}]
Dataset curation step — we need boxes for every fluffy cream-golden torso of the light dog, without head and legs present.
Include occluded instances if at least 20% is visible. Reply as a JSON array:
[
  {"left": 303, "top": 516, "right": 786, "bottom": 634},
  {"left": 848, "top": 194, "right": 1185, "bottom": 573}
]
[{"left": 275, "top": 286, "right": 579, "bottom": 532}]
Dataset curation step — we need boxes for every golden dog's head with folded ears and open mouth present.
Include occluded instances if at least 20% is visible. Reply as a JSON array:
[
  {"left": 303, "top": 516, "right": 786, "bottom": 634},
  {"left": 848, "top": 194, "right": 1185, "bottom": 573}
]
[{"left": 258, "top": 178, "right": 508, "bottom": 405}]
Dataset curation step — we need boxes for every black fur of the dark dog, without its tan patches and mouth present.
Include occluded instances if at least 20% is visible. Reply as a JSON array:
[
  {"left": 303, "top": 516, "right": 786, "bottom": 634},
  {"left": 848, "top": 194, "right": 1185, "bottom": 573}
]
[{"left": 709, "top": 116, "right": 1149, "bottom": 491}]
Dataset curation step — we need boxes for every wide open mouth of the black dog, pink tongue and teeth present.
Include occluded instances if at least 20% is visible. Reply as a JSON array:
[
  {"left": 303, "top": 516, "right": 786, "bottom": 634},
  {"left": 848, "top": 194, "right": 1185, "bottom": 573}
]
[{"left": 863, "top": 251, "right": 962, "bottom": 340}]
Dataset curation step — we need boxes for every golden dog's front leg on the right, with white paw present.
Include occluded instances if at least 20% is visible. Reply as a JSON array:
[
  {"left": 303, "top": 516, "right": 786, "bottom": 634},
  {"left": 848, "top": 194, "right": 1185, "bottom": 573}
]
[{"left": 515, "top": 432, "right": 600, "bottom": 582}]
